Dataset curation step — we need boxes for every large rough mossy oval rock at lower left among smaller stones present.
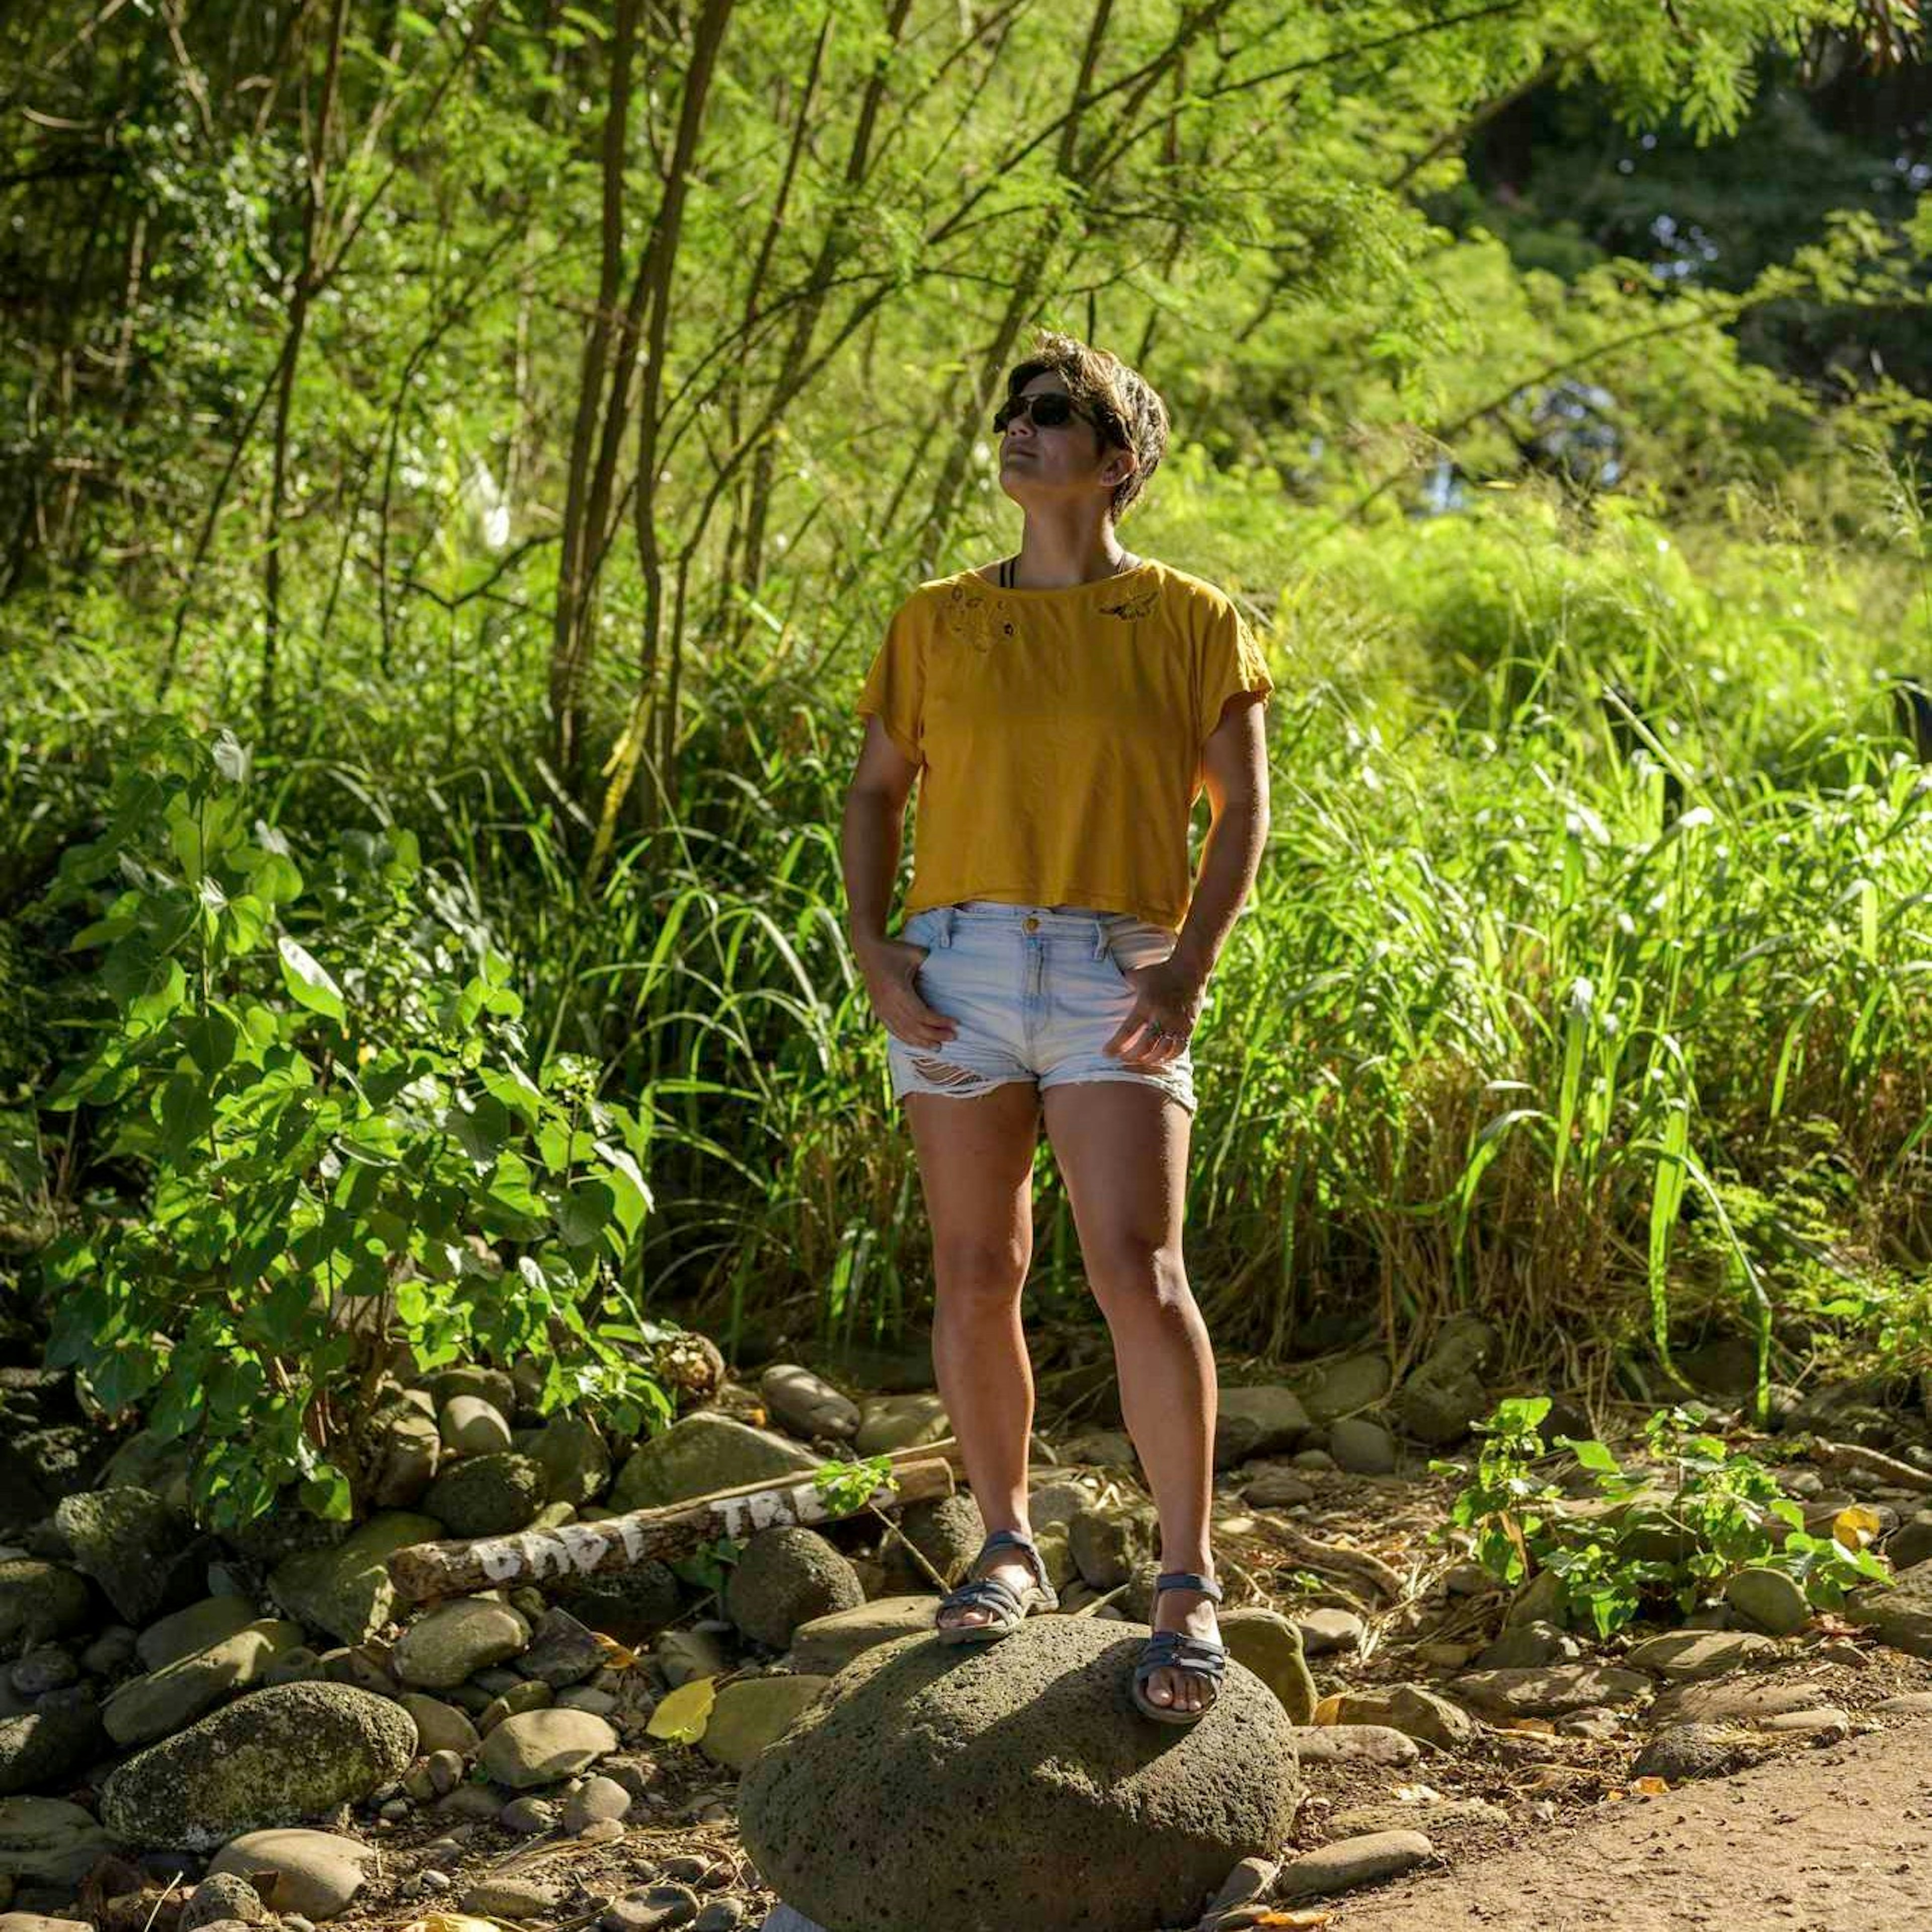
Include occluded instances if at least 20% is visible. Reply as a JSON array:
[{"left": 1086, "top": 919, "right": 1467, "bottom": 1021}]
[{"left": 101, "top": 1683, "right": 416, "bottom": 1851}]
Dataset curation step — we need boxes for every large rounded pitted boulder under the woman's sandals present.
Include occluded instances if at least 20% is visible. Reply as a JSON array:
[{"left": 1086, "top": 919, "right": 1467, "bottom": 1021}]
[{"left": 738, "top": 1617, "right": 1298, "bottom": 1932}]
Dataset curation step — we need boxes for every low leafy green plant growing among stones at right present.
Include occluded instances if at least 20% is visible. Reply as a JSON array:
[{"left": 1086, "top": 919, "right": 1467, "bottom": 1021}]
[{"left": 1430, "top": 1397, "right": 1890, "bottom": 1636}]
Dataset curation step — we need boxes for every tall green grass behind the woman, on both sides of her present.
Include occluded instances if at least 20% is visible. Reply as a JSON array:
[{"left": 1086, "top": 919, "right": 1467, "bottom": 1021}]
[{"left": 0, "top": 452, "right": 1932, "bottom": 1406}]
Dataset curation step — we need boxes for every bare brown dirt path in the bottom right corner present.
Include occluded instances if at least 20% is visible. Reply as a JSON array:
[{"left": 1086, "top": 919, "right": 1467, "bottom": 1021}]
[{"left": 1333, "top": 1720, "right": 1932, "bottom": 1932}]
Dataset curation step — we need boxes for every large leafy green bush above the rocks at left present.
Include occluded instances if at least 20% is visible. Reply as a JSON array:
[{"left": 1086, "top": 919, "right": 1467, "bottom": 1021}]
[{"left": 30, "top": 722, "right": 670, "bottom": 1526}]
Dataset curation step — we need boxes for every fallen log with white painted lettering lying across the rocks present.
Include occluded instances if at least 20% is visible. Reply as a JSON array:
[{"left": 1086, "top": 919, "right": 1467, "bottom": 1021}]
[{"left": 388, "top": 1437, "right": 958, "bottom": 1603}]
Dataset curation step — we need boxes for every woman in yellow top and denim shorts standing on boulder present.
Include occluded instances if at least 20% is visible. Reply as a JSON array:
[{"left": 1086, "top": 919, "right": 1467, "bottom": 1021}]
[{"left": 842, "top": 334, "right": 1273, "bottom": 1723}]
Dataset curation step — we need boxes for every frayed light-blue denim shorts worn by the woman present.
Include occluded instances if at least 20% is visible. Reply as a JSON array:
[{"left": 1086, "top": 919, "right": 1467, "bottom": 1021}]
[{"left": 887, "top": 899, "right": 1194, "bottom": 1113}]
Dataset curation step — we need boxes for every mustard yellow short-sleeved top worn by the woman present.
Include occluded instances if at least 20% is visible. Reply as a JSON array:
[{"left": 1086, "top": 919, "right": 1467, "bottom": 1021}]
[{"left": 854, "top": 560, "right": 1275, "bottom": 931}]
